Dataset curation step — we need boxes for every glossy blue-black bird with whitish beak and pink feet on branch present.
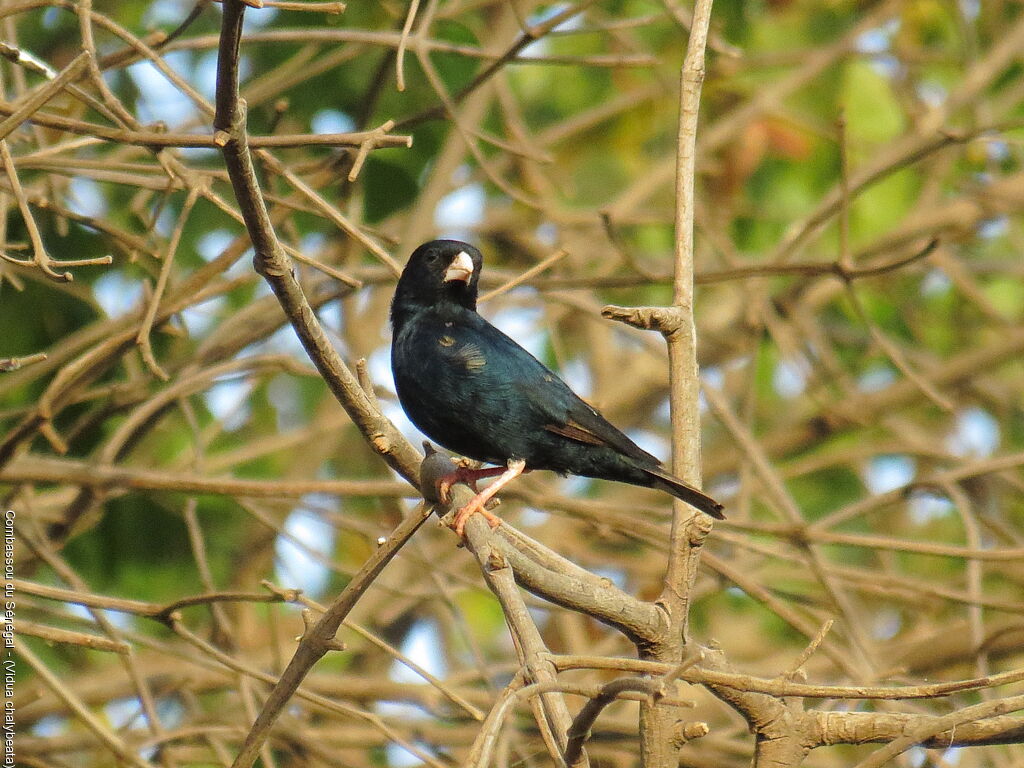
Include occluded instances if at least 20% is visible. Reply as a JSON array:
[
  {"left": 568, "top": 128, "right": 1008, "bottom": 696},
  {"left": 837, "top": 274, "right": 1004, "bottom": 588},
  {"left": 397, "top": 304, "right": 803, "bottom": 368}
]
[{"left": 391, "top": 240, "right": 724, "bottom": 536}]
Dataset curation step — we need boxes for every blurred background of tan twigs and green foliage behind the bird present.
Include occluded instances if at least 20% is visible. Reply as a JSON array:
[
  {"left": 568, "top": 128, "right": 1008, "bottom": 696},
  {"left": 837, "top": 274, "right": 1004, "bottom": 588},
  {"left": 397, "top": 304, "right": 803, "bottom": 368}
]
[{"left": 0, "top": 0, "right": 1024, "bottom": 766}]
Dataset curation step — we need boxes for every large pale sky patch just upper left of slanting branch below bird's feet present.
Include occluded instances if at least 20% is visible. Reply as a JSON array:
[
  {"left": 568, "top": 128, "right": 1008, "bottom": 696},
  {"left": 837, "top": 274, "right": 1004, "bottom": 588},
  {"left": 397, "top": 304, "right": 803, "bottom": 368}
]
[{"left": 273, "top": 501, "right": 339, "bottom": 597}]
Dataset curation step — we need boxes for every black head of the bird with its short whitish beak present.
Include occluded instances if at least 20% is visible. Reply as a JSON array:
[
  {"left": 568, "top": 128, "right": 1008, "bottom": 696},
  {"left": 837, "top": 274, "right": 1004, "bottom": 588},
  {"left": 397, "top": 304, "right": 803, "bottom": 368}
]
[{"left": 391, "top": 240, "right": 483, "bottom": 317}]
